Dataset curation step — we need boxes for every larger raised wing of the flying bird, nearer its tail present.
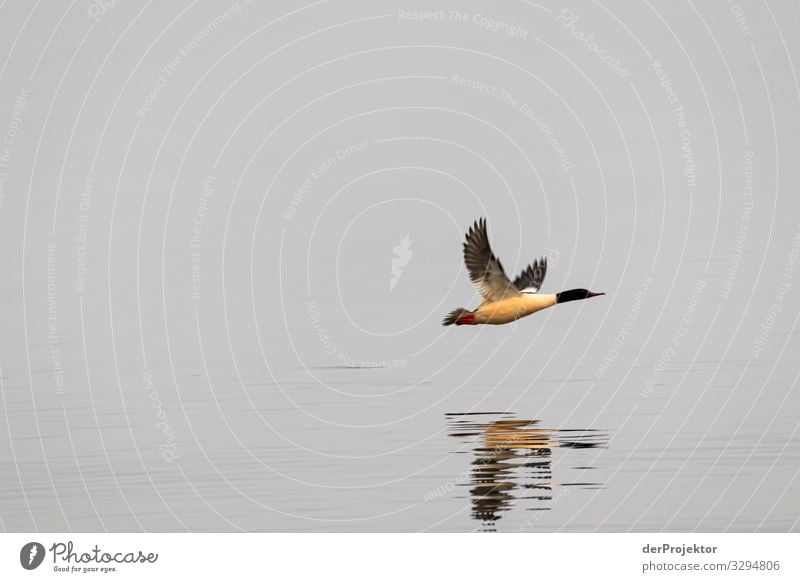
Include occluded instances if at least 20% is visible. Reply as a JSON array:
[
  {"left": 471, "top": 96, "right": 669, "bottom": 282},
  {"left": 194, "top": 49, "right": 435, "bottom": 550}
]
[{"left": 464, "top": 218, "right": 520, "bottom": 301}]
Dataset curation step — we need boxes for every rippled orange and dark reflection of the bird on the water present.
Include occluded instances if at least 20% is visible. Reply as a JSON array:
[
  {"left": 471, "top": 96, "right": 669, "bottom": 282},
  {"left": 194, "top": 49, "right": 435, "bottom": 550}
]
[{"left": 448, "top": 413, "right": 605, "bottom": 531}]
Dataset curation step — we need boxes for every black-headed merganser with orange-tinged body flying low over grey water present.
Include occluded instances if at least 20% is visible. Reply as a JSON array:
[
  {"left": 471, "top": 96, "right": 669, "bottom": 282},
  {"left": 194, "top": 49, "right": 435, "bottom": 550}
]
[{"left": 442, "top": 218, "right": 605, "bottom": 325}]
